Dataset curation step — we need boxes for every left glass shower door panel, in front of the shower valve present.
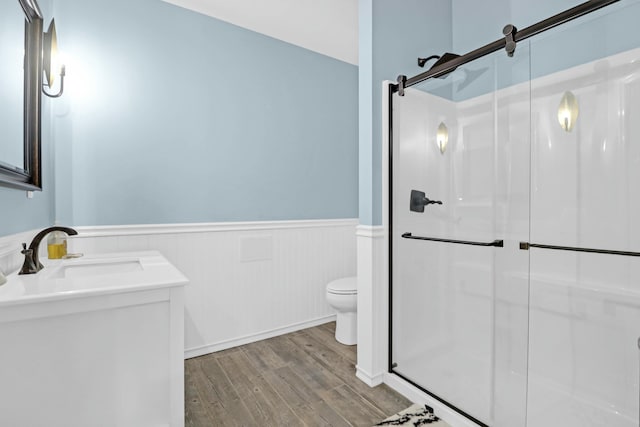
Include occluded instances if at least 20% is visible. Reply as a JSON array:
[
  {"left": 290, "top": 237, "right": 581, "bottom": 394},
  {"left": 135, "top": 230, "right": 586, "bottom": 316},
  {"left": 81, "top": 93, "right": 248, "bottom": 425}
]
[{"left": 390, "top": 43, "right": 530, "bottom": 427}]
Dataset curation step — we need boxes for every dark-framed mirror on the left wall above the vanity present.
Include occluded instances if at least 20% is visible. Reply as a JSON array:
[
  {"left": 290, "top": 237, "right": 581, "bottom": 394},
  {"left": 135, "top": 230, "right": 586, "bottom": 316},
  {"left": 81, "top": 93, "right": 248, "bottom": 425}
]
[{"left": 0, "top": 0, "right": 43, "bottom": 191}]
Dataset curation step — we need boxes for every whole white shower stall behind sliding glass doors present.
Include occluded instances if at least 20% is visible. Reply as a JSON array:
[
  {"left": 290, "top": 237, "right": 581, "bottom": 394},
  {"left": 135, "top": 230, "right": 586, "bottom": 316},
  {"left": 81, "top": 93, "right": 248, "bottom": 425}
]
[{"left": 386, "top": 1, "right": 640, "bottom": 427}]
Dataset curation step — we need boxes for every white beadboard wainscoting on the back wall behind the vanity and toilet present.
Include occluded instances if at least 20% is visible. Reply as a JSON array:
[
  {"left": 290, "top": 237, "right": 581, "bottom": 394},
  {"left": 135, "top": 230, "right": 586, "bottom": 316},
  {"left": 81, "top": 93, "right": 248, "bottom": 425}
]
[{"left": 64, "top": 219, "right": 357, "bottom": 358}]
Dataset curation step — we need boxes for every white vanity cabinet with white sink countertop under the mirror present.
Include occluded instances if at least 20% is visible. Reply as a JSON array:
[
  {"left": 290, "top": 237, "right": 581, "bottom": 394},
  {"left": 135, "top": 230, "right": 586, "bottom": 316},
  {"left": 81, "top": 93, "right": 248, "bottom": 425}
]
[{"left": 0, "top": 252, "right": 187, "bottom": 427}]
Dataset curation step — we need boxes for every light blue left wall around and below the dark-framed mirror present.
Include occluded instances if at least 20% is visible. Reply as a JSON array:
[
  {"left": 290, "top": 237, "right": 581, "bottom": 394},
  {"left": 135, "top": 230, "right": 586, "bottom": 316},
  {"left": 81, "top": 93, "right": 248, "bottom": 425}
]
[{"left": 0, "top": 0, "right": 55, "bottom": 236}]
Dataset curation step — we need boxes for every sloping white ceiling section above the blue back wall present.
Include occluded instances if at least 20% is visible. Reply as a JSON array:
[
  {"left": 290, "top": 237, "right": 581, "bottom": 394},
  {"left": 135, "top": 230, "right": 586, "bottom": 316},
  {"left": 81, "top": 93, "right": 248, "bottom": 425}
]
[{"left": 163, "top": 0, "right": 358, "bottom": 65}]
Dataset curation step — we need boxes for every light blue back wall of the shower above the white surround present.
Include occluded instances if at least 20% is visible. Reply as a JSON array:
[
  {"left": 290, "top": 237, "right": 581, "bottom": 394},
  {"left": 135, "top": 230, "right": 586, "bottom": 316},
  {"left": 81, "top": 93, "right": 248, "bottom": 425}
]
[{"left": 453, "top": 0, "right": 640, "bottom": 101}]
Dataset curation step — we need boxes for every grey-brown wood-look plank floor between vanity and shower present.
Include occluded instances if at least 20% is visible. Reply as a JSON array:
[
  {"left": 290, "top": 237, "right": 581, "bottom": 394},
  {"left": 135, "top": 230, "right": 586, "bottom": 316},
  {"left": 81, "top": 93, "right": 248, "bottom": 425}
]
[{"left": 185, "top": 322, "right": 411, "bottom": 427}]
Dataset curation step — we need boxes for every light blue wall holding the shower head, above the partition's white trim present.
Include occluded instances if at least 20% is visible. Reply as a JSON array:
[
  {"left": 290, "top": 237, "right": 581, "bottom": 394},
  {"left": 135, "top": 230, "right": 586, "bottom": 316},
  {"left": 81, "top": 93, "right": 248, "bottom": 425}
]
[{"left": 359, "top": 0, "right": 452, "bottom": 225}]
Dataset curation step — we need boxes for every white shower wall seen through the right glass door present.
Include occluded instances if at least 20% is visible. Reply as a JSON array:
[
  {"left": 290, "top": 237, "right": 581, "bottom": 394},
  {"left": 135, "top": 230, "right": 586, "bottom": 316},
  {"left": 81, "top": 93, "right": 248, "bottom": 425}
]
[{"left": 527, "top": 49, "right": 640, "bottom": 427}]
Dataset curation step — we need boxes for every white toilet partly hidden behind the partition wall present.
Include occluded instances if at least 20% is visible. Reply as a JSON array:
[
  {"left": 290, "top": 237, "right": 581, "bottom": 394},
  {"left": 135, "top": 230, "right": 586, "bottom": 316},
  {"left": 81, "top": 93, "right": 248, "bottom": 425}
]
[{"left": 327, "top": 277, "right": 358, "bottom": 345}]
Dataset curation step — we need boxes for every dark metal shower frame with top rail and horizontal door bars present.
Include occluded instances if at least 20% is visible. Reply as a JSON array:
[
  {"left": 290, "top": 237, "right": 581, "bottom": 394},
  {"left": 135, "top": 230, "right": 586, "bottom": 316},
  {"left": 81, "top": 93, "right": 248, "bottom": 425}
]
[{"left": 387, "top": 0, "right": 624, "bottom": 427}]
